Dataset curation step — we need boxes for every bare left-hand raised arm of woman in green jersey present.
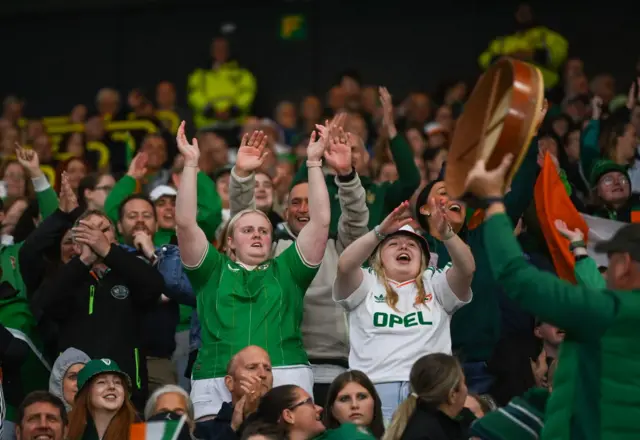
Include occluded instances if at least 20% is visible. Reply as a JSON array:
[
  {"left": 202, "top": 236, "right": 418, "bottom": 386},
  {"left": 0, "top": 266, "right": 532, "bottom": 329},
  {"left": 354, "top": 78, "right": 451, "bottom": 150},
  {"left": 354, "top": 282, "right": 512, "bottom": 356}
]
[{"left": 176, "top": 121, "right": 208, "bottom": 267}]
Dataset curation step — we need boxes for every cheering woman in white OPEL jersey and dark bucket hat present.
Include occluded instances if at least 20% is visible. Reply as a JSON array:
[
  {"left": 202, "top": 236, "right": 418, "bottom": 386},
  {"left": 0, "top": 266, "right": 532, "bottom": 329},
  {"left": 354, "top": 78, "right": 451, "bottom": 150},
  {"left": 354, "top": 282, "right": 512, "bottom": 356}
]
[{"left": 333, "top": 199, "right": 475, "bottom": 421}]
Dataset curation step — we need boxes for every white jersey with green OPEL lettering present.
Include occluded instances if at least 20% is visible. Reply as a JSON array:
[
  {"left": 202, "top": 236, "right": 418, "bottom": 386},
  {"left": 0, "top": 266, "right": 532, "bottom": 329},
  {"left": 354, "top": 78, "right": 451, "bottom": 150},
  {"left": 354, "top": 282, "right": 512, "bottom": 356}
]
[{"left": 334, "top": 264, "right": 471, "bottom": 383}]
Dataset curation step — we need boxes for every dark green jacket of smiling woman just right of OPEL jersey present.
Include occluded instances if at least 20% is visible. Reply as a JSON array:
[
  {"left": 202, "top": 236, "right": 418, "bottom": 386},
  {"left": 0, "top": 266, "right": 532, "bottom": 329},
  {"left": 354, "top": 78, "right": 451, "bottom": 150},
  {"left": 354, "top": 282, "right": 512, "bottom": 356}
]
[{"left": 429, "top": 140, "right": 540, "bottom": 362}]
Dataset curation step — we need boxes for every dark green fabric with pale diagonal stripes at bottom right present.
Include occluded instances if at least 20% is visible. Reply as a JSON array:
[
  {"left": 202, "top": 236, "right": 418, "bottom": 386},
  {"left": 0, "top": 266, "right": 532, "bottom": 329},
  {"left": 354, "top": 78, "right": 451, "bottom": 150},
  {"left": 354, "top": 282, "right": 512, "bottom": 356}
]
[{"left": 470, "top": 388, "right": 549, "bottom": 440}]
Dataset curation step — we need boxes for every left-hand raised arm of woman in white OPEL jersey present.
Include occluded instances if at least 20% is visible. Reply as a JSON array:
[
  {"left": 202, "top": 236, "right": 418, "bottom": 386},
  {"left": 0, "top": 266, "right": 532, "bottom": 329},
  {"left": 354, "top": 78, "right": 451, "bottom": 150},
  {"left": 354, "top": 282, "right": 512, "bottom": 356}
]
[{"left": 334, "top": 202, "right": 411, "bottom": 301}]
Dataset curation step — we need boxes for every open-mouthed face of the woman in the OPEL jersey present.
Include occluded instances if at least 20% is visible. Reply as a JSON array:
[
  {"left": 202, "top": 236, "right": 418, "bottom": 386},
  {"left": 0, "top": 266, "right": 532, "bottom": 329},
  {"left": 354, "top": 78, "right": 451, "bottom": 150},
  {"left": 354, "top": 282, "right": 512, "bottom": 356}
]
[{"left": 380, "top": 233, "right": 422, "bottom": 282}]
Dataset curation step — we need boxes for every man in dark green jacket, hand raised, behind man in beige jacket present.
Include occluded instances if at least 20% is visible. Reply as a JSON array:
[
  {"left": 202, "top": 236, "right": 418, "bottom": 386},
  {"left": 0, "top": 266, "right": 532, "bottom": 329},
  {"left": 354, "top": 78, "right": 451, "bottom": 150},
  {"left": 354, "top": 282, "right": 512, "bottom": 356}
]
[{"left": 291, "top": 87, "right": 420, "bottom": 236}]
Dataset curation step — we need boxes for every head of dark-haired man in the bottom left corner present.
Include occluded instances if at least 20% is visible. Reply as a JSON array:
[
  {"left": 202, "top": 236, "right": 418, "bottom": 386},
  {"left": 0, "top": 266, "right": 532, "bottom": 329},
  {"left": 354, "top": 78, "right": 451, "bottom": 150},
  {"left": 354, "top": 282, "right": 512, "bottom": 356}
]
[{"left": 16, "top": 391, "right": 69, "bottom": 440}]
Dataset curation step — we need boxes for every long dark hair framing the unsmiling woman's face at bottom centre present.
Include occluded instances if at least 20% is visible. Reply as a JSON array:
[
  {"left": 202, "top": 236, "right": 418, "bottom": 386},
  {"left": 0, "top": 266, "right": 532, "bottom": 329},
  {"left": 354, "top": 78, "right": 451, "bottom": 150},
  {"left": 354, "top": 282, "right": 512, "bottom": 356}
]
[{"left": 322, "top": 370, "right": 384, "bottom": 438}]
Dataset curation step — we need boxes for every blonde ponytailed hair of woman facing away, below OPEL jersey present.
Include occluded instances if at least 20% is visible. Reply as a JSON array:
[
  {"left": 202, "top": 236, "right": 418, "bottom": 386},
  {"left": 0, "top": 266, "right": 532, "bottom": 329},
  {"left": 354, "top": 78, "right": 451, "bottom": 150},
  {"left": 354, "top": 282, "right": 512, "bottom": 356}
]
[{"left": 382, "top": 353, "right": 464, "bottom": 440}]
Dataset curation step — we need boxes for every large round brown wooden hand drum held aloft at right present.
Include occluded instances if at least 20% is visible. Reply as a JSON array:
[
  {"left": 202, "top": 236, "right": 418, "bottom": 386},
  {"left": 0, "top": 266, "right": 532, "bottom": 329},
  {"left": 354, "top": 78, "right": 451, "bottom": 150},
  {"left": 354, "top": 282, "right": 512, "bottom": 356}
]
[{"left": 445, "top": 58, "right": 544, "bottom": 199}]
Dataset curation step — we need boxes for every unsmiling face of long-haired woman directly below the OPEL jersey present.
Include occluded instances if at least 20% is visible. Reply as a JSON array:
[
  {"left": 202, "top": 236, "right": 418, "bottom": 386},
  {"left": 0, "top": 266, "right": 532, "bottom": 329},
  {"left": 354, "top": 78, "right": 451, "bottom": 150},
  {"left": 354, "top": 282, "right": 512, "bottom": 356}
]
[{"left": 331, "top": 382, "right": 375, "bottom": 426}]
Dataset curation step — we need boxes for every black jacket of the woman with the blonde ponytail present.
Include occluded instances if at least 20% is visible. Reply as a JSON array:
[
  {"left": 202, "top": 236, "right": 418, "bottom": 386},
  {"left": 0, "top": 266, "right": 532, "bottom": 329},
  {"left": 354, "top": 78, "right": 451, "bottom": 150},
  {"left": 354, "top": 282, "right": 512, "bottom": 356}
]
[{"left": 400, "top": 401, "right": 469, "bottom": 440}]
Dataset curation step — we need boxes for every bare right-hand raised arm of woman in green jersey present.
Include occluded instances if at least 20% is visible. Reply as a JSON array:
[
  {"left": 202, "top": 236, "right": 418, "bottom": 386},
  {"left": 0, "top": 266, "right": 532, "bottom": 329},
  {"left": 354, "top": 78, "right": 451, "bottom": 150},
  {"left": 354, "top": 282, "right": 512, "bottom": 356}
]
[{"left": 296, "top": 127, "right": 332, "bottom": 266}]
